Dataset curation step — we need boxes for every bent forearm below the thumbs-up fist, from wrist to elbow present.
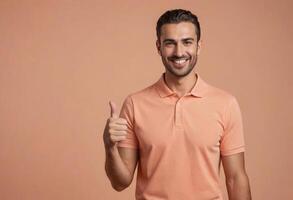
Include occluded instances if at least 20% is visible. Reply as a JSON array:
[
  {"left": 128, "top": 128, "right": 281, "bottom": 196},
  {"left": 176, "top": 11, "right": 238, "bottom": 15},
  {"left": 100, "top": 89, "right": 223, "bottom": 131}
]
[{"left": 105, "top": 144, "right": 131, "bottom": 191}]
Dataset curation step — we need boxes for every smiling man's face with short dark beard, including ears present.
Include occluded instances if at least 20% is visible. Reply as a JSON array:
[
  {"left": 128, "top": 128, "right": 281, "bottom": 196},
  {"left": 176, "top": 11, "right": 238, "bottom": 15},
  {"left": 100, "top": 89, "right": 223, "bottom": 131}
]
[{"left": 156, "top": 22, "right": 201, "bottom": 77}]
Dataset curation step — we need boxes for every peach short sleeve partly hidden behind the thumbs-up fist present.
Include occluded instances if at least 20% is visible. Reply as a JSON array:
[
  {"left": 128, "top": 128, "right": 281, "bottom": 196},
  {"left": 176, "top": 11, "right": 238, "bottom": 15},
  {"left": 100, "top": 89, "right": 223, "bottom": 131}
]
[{"left": 117, "top": 96, "right": 138, "bottom": 149}]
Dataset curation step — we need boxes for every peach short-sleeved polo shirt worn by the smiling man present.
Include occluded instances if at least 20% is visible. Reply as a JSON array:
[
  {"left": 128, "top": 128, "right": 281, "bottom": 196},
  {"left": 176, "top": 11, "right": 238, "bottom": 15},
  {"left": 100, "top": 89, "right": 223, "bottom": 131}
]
[{"left": 118, "top": 73, "right": 245, "bottom": 200}]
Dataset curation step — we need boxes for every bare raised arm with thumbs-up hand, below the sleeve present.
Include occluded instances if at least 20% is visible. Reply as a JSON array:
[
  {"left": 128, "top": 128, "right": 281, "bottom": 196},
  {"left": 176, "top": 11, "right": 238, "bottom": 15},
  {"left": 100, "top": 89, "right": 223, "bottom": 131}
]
[{"left": 103, "top": 102, "right": 138, "bottom": 191}]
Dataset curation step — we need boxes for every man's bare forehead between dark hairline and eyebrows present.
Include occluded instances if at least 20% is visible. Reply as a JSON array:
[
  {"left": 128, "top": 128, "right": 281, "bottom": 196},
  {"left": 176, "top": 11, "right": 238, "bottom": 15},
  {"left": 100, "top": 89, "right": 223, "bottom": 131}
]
[{"left": 161, "top": 22, "right": 196, "bottom": 39}]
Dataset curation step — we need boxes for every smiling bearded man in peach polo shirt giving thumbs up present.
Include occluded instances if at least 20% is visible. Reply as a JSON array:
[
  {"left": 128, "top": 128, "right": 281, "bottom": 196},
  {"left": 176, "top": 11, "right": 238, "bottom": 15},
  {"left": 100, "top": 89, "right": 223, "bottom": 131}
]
[{"left": 104, "top": 9, "right": 251, "bottom": 200}]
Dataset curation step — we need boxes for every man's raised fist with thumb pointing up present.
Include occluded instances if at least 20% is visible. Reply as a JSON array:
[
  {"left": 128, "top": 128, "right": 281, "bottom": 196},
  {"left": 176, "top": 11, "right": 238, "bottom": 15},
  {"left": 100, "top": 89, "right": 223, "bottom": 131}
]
[{"left": 103, "top": 101, "right": 127, "bottom": 148}]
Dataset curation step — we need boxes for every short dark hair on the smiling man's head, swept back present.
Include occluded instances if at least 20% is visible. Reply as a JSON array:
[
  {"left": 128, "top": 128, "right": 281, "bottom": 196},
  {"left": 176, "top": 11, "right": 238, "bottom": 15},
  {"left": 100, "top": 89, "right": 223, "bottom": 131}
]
[{"left": 156, "top": 9, "right": 200, "bottom": 41}]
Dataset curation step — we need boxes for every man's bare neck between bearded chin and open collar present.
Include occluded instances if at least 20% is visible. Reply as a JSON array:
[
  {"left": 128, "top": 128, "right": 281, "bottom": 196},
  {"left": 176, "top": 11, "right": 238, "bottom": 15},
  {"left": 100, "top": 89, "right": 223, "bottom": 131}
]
[{"left": 164, "top": 71, "right": 197, "bottom": 97}]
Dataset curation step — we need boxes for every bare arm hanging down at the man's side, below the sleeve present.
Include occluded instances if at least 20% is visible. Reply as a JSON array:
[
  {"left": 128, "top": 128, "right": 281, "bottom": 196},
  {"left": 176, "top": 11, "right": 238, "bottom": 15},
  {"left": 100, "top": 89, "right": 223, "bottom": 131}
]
[{"left": 222, "top": 152, "right": 251, "bottom": 200}]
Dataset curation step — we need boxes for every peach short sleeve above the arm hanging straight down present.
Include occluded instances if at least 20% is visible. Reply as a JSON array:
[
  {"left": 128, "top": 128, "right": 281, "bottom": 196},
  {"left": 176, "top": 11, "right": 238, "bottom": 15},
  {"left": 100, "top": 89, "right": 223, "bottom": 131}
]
[{"left": 220, "top": 97, "right": 245, "bottom": 156}]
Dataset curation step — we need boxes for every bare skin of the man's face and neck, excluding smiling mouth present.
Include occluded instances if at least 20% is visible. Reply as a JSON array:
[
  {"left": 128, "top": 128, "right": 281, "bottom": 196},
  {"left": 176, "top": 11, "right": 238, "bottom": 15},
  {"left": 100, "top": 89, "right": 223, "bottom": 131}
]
[{"left": 156, "top": 22, "right": 202, "bottom": 97}]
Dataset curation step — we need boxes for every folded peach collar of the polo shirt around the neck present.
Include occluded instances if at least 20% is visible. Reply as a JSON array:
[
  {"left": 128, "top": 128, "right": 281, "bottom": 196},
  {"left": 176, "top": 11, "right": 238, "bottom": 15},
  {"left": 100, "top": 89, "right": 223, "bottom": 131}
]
[{"left": 155, "top": 72, "right": 208, "bottom": 97}]
